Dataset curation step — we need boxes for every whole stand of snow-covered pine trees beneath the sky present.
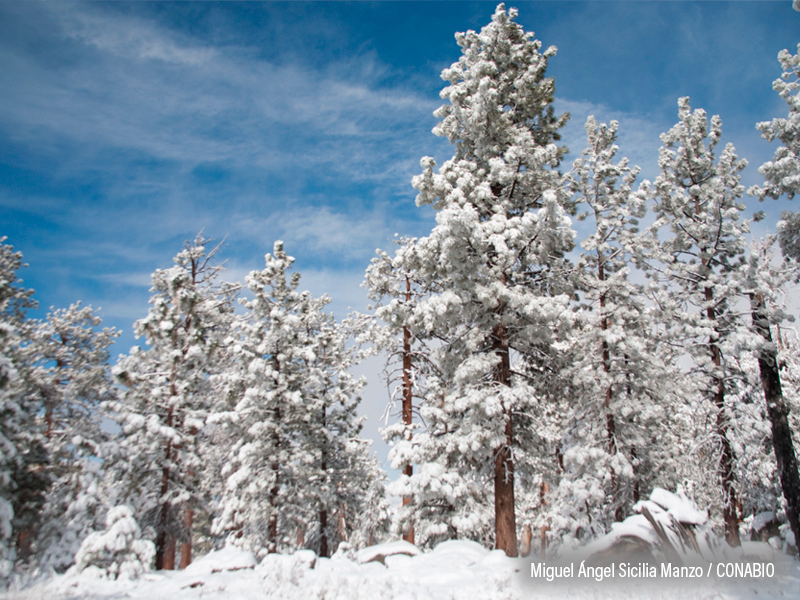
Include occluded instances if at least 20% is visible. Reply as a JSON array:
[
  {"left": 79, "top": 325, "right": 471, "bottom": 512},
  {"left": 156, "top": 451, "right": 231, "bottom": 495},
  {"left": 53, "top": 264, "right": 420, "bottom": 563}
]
[{"left": 0, "top": 4, "right": 800, "bottom": 579}]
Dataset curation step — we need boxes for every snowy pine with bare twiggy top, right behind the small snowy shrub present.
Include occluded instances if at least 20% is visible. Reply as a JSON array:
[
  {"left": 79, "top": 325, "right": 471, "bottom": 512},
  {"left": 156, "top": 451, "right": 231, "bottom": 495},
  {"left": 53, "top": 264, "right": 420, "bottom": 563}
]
[{"left": 108, "top": 235, "right": 238, "bottom": 569}]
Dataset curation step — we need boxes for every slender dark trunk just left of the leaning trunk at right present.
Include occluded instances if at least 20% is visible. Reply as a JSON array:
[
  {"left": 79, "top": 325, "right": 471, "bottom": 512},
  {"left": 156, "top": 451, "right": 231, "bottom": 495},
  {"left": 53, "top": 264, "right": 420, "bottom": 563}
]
[{"left": 705, "top": 287, "right": 741, "bottom": 547}]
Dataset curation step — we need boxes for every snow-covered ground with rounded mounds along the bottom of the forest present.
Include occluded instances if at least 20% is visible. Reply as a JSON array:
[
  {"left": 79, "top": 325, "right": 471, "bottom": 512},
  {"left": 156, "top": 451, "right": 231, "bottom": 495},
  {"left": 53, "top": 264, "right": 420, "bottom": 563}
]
[{"left": 0, "top": 541, "right": 800, "bottom": 600}]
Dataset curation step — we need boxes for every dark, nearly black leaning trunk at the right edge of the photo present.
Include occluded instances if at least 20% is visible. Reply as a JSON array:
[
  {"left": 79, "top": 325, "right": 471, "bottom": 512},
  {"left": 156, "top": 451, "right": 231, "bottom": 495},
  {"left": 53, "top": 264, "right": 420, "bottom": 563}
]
[{"left": 750, "top": 294, "right": 800, "bottom": 544}]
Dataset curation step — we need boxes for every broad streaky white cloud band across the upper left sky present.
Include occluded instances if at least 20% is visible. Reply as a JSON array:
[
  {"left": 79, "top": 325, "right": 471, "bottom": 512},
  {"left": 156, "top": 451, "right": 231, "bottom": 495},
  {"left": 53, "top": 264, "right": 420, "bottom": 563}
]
[{"left": 0, "top": 5, "right": 437, "bottom": 186}]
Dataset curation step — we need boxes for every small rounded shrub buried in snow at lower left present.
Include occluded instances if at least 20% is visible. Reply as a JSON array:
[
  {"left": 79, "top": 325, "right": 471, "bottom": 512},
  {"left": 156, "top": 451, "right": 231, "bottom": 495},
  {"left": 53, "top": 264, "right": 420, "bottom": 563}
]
[{"left": 70, "top": 506, "right": 156, "bottom": 579}]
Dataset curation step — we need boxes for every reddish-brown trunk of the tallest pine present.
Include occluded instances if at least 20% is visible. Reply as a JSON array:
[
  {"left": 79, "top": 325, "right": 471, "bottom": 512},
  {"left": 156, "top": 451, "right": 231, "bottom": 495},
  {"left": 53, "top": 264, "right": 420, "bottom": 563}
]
[{"left": 493, "top": 323, "right": 517, "bottom": 557}]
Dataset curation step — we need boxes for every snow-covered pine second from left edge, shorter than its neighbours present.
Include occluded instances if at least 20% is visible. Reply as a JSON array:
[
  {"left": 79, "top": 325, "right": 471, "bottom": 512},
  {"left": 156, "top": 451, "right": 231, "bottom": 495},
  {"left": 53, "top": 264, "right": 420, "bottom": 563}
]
[{"left": 24, "top": 303, "right": 119, "bottom": 571}]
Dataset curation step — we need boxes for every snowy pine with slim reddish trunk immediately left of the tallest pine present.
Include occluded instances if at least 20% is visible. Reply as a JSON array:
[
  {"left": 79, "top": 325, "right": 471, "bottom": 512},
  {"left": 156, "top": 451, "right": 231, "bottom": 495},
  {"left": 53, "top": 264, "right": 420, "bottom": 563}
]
[{"left": 360, "top": 238, "right": 492, "bottom": 548}]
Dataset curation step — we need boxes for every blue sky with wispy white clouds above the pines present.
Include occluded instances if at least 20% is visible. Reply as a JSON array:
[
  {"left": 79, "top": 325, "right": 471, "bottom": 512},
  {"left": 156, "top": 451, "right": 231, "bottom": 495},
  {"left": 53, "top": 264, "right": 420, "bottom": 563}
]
[{"left": 0, "top": 0, "right": 800, "bottom": 468}]
